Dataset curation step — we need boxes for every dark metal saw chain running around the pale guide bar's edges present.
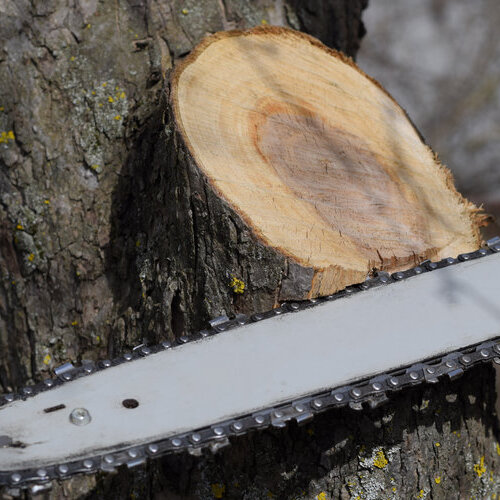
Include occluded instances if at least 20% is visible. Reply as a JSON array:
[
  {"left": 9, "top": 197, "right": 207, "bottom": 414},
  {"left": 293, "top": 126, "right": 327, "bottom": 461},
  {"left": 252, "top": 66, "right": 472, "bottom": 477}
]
[{"left": 0, "top": 237, "right": 500, "bottom": 492}]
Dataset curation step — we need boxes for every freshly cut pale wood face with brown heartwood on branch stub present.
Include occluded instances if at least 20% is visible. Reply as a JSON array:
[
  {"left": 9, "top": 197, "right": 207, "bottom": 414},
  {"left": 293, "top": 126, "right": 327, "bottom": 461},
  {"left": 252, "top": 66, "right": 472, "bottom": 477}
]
[{"left": 171, "top": 28, "right": 480, "bottom": 297}]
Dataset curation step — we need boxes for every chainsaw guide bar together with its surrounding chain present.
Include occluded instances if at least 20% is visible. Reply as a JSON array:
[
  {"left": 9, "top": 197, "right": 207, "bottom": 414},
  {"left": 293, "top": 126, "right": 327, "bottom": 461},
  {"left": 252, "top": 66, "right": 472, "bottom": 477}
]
[{"left": 0, "top": 237, "right": 500, "bottom": 488}]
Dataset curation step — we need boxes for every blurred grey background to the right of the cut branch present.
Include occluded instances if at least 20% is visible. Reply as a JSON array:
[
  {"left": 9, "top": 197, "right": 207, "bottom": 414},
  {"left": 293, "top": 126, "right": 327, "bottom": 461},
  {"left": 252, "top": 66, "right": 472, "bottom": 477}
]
[{"left": 357, "top": 0, "right": 500, "bottom": 235}]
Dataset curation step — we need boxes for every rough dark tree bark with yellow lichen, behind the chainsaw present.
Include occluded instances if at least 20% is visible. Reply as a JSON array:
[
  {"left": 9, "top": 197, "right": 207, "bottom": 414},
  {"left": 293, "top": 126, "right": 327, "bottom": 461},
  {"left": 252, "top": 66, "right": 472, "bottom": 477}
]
[{"left": 0, "top": 0, "right": 500, "bottom": 500}]
